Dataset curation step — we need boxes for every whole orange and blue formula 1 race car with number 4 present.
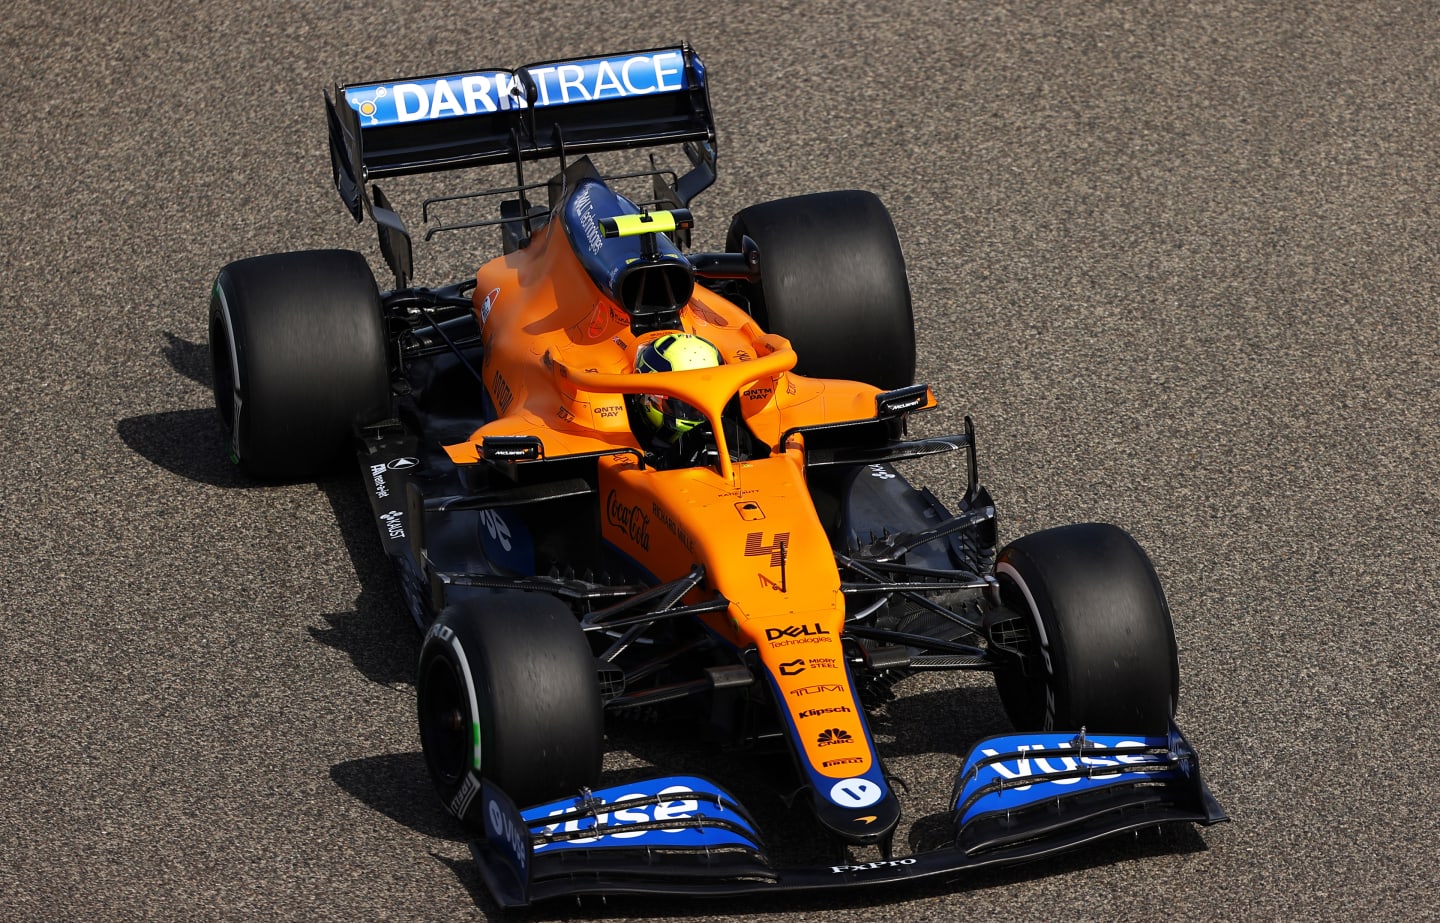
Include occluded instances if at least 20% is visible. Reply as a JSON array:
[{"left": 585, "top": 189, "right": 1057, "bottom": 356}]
[{"left": 210, "top": 45, "right": 1225, "bottom": 907}]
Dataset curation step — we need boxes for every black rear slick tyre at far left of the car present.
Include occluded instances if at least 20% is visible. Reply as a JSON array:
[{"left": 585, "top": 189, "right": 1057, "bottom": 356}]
[{"left": 210, "top": 251, "right": 390, "bottom": 479}]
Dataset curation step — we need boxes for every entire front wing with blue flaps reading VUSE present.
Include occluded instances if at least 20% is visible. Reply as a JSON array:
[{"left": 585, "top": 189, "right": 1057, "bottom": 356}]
[{"left": 451, "top": 727, "right": 1228, "bottom": 907}]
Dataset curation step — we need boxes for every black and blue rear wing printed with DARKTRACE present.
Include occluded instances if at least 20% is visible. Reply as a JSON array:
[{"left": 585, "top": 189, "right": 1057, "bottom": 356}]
[{"left": 325, "top": 45, "right": 716, "bottom": 222}]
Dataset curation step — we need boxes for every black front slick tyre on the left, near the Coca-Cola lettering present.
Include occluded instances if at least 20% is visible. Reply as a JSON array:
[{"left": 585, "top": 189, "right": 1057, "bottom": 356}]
[{"left": 418, "top": 593, "right": 605, "bottom": 806}]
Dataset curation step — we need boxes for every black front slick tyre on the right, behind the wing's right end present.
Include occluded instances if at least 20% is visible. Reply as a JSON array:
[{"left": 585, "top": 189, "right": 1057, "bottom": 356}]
[{"left": 995, "top": 523, "right": 1179, "bottom": 734}]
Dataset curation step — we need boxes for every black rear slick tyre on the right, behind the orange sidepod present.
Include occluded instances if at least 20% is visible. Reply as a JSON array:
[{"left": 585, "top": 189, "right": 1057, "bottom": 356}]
[{"left": 726, "top": 190, "right": 914, "bottom": 390}]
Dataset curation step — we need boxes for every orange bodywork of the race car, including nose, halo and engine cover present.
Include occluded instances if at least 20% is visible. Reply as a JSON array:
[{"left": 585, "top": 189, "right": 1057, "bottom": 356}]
[{"left": 446, "top": 204, "right": 933, "bottom": 779}]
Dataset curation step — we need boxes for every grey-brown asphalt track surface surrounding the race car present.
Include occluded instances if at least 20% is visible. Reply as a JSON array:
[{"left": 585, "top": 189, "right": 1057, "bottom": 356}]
[{"left": 0, "top": 0, "right": 1440, "bottom": 923}]
